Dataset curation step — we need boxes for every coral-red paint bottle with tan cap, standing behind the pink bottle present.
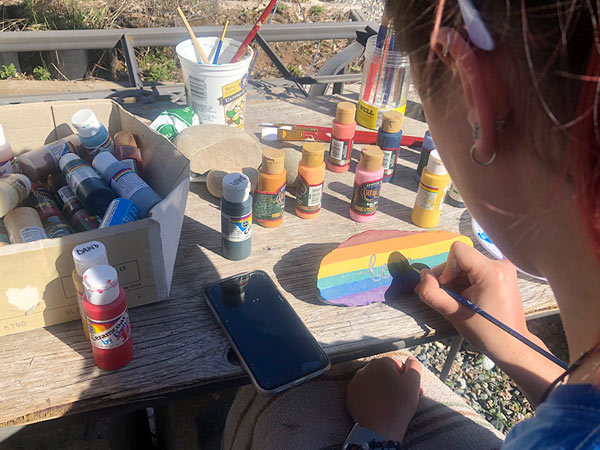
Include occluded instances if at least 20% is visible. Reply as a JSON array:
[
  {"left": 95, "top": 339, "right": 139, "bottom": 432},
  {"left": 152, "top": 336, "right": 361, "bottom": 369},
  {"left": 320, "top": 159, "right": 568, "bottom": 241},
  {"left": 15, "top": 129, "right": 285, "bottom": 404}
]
[{"left": 327, "top": 102, "right": 356, "bottom": 172}]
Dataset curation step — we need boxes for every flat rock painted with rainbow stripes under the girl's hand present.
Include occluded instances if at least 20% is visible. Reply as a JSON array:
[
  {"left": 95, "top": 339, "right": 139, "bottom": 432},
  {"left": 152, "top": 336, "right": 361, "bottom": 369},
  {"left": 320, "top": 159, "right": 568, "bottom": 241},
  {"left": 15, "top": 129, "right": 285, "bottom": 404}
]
[{"left": 317, "top": 231, "right": 473, "bottom": 306}]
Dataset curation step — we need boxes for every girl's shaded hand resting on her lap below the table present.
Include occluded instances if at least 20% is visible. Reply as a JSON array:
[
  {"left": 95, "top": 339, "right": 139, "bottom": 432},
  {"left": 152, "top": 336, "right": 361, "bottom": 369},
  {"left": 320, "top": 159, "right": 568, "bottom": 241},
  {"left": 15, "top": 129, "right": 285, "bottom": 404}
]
[{"left": 346, "top": 356, "right": 421, "bottom": 442}]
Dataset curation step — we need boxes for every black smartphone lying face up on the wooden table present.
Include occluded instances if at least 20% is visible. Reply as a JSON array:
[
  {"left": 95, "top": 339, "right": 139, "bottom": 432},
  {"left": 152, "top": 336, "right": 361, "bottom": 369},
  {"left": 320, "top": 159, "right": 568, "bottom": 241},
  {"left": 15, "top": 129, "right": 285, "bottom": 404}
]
[{"left": 204, "top": 270, "right": 331, "bottom": 394}]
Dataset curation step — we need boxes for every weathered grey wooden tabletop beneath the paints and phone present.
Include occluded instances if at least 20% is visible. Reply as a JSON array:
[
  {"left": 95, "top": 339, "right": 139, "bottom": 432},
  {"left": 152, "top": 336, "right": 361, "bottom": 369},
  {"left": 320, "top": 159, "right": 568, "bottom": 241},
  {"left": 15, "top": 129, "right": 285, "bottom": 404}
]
[{"left": 0, "top": 85, "right": 556, "bottom": 427}]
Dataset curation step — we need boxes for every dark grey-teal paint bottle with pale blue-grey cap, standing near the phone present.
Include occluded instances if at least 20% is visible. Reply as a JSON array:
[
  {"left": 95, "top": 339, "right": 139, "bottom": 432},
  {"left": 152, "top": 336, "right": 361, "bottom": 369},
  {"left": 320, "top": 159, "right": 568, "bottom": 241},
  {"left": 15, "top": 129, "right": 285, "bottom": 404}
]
[{"left": 221, "top": 173, "right": 252, "bottom": 261}]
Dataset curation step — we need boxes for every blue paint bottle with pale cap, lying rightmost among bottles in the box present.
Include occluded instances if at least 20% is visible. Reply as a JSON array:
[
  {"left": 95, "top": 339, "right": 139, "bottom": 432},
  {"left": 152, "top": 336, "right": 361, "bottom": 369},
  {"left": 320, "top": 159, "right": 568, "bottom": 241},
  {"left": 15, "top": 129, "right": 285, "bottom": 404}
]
[{"left": 92, "top": 152, "right": 162, "bottom": 218}]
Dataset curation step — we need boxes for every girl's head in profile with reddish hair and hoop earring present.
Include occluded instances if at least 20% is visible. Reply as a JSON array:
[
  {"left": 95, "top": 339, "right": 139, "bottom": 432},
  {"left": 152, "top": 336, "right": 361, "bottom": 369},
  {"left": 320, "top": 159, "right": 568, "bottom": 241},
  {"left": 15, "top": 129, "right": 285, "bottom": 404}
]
[{"left": 389, "top": 0, "right": 600, "bottom": 273}]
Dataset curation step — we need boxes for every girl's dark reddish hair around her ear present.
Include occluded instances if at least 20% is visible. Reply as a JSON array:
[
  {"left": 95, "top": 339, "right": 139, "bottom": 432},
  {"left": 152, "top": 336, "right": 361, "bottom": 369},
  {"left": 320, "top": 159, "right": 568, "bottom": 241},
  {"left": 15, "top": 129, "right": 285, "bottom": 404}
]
[{"left": 388, "top": 0, "right": 600, "bottom": 258}]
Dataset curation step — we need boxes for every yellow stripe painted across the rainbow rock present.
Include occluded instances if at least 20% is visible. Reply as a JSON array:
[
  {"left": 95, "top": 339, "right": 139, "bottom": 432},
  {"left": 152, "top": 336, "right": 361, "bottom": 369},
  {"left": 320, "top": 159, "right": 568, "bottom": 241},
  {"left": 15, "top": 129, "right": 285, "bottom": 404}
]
[{"left": 317, "top": 236, "right": 473, "bottom": 279}]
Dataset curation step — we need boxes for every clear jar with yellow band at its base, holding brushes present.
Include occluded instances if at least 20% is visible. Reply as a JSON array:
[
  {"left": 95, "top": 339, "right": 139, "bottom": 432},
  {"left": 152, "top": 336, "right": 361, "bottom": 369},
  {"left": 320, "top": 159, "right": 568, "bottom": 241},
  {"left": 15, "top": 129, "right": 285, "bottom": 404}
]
[{"left": 356, "top": 36, "right": 410, "bottom": 130}]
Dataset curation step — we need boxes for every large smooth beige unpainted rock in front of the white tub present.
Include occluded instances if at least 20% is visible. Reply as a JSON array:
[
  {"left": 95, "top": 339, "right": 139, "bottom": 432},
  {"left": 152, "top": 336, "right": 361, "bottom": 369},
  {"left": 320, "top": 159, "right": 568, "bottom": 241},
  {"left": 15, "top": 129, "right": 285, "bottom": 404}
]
[{"left": 173, "top": 124, "right": 262, "bottom": 175}]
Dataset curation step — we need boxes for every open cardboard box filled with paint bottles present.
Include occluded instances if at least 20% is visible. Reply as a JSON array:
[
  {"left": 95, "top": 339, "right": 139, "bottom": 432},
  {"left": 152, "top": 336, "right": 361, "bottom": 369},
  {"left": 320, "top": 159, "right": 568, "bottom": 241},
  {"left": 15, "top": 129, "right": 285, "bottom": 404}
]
[{"left": 0, "top": 100, "right": 190, "bottom": 336}]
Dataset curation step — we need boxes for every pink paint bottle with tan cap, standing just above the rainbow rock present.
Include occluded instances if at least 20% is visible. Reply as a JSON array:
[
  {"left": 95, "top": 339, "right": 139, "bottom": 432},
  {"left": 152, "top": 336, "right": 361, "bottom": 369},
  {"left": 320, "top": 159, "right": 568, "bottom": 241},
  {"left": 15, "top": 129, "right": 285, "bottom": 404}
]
[{"left": 350, "top": 145, "right": 383, "bottom": 222}]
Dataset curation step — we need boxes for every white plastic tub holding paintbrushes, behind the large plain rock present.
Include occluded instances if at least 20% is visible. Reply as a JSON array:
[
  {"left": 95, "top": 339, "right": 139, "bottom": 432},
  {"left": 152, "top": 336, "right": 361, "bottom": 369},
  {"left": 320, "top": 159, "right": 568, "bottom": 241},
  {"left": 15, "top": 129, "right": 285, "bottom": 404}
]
[{"left": 175, "top": 37, "right": 253, "bottom": 129}]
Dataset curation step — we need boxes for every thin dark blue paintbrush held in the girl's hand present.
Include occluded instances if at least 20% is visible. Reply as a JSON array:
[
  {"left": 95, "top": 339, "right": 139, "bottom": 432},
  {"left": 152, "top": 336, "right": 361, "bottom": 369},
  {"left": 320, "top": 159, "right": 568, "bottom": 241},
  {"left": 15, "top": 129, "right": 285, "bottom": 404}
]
[{"left": 388, "top": 252, "right": 568, "bottom": 369}]
